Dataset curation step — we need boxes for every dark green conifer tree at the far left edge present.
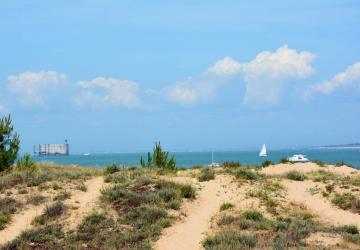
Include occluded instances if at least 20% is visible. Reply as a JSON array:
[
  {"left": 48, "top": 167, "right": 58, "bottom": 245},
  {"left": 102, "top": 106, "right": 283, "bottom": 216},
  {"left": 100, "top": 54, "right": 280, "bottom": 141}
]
[{"left": 0, "top": 115, "right": 20, "bottom": 171}]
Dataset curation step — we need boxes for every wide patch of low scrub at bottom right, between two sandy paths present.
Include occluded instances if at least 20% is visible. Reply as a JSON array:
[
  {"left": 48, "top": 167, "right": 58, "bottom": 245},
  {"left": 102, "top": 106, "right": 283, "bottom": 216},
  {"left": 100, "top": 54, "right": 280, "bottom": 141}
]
[{"left": 203, "top": 207, "right": 344, "bottom": 249}]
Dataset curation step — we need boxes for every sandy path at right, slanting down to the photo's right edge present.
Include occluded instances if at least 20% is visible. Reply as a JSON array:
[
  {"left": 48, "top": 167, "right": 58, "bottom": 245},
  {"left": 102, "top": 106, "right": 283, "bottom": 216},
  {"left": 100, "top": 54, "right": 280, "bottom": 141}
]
[{"left": 283, "top": 180, "right": 360, "bottom": 227}]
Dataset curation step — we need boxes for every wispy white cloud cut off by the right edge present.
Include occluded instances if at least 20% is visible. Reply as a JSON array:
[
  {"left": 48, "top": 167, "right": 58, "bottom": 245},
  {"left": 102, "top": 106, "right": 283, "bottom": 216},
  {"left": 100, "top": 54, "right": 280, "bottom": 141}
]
[{"left": 305, "top": 62, "right": 360, "bottom": 98}]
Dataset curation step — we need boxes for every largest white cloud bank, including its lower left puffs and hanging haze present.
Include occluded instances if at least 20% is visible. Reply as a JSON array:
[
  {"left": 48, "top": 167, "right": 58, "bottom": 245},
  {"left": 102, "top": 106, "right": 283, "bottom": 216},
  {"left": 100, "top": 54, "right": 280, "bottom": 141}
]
[{"left": 167, "top": 45, "right": 315, "bottom": 106}]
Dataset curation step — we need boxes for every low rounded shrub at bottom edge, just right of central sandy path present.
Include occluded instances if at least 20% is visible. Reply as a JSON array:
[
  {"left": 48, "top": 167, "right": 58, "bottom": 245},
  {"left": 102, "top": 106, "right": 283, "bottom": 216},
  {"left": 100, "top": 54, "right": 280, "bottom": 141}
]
[{"left": 203, "top": 230, "right": 257, "bottom": 250}]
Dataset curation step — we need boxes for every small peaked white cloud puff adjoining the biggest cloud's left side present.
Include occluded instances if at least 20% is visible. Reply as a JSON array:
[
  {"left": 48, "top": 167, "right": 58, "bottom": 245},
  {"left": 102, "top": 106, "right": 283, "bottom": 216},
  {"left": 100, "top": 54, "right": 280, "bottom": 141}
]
[{"left": 208, "top": 56, "right": 243, "bottom": 75}]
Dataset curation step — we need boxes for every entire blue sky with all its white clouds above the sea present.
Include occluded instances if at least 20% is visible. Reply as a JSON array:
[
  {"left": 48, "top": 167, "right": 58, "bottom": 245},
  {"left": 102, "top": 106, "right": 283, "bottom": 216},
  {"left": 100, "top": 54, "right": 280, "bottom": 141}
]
[{"left": 0, "top": 0, "right": 360, "bottom": 153}]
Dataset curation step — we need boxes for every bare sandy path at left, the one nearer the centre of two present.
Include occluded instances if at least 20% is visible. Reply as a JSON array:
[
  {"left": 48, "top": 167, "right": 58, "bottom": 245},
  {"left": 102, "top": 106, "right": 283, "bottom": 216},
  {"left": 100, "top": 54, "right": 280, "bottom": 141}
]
[{"left": 64, "top": 176, "right": 104, "bottom": 229}]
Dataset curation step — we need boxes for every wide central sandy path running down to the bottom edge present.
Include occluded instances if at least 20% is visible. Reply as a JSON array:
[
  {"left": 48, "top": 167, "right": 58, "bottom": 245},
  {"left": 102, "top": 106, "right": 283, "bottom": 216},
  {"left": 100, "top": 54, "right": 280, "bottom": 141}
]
[{"left": 155, "top": 175, "right": 236, "bottom": 250}]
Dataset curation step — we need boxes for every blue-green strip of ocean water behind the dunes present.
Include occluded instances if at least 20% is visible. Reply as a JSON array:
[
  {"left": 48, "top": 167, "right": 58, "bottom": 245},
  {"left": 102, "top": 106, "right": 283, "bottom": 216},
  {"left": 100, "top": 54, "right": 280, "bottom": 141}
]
[{"left": 35, "top": 148, "right": 360, "bottom": 169}]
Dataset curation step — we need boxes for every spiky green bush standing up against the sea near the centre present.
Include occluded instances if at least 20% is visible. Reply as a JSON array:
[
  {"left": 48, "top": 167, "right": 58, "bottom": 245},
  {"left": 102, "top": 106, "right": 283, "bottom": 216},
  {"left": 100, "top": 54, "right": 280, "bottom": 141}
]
[{"left": 140, "top": 142, "right": 176, "bottom": 171}]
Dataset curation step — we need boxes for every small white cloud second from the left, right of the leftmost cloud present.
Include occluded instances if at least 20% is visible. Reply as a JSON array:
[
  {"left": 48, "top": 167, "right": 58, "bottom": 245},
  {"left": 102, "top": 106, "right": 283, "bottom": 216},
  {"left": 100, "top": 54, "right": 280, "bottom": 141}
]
[{"left": 76, "top": 77, "right": 141, "bottom": 108}]
